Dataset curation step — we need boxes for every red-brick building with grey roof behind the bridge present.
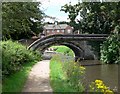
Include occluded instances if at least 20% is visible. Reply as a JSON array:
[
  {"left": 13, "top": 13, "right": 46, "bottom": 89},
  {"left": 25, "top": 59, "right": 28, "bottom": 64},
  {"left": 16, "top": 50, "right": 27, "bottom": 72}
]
[{"left": 43, "top": 24, "right": 73, "bottom": 36}]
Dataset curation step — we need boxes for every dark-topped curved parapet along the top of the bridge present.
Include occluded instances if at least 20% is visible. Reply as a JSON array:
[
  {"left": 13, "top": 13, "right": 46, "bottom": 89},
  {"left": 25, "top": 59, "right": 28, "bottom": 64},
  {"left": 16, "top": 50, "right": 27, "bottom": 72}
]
[{"left": 28, "top": 34, "right": 108, "bottom": 49}]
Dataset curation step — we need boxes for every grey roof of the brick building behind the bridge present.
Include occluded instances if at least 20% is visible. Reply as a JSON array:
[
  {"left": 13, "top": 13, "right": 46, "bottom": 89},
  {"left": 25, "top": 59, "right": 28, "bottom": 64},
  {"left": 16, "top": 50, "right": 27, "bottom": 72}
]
[{"left": 44, "top": 24, "right": 69, "bottom": 29}]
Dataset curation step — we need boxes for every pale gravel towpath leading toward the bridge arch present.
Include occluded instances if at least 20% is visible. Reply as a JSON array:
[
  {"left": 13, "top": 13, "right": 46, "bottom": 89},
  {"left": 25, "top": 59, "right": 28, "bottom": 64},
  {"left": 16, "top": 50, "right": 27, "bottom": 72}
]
[{"left": 23, "top": 60, "right": 52, "bottom": 92}]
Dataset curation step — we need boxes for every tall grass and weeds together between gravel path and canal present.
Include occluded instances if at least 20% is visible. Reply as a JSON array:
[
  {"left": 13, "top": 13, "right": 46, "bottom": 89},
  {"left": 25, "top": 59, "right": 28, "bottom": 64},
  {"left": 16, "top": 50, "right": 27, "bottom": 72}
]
[{"left": 50, "top": 55, "right": 85, "bottom": 92}]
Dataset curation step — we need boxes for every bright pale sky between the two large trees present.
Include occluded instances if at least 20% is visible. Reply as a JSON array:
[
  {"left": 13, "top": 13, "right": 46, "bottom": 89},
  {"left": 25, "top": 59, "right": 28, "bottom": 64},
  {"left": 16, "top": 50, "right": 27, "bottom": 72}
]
[{"left": 37, "top": 0, "right": 78, "bottom": 22}]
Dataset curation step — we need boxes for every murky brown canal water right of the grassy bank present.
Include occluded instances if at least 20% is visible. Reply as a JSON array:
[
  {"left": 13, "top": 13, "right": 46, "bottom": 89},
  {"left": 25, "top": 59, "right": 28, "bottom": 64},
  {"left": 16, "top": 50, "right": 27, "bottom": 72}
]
[{"left": 80, "top": 60, "right": 118, "bottom": 91}]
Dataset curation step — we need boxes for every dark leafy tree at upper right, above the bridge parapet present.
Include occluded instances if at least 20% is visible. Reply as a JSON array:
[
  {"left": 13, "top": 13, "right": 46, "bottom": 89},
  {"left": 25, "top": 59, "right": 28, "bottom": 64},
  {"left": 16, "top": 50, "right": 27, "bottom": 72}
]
[{"left": 61, "top": 2, "right": 120, "bottom": 34}]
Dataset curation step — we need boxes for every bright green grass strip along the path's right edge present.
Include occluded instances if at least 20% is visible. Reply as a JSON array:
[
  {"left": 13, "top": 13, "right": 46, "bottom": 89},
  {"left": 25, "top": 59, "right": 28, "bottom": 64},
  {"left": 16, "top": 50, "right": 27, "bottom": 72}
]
[{"left": 50, "top": 56, "right": 75, "bottom": 93}]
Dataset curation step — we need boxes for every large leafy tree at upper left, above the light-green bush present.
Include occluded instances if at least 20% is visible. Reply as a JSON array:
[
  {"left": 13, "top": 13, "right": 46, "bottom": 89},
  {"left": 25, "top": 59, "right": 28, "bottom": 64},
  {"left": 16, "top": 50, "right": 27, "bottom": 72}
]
[{"left": 2, "top": 2, "right": 43, "bottom": 40}]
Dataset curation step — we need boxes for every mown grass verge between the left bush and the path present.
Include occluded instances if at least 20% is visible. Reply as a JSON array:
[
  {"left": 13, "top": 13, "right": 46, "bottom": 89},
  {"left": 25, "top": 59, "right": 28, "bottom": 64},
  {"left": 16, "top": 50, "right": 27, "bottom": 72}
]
[{"left": 2, "top": 61, "right": 36, "bottom": 94}]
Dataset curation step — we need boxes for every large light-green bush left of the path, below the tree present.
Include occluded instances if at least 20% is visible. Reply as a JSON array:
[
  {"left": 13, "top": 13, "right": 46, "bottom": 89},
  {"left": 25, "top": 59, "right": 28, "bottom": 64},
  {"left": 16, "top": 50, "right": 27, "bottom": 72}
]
[{"left": 1, "top": 40, "right": 40, "bottom": 76}]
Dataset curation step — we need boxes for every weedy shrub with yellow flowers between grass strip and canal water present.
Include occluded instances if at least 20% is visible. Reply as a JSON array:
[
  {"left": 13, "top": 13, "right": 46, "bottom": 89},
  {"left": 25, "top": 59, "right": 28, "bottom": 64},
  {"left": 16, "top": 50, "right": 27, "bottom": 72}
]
[{"left": 62, "top": 58, "right": 85, "bottom": 92}]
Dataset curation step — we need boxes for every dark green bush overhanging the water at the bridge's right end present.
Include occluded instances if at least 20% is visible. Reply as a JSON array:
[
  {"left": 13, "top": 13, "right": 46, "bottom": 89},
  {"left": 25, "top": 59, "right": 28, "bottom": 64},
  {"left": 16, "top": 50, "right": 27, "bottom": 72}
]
[{"left": 101, "top": 34, "right": 120, "bottom": 64}]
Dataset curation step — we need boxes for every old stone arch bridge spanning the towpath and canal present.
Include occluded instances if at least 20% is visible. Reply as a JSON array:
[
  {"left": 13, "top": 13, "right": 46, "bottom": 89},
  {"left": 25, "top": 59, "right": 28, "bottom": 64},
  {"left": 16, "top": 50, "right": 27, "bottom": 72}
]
[{"left": 28, "top": 34, "right": 108, "bottom": 59}]
